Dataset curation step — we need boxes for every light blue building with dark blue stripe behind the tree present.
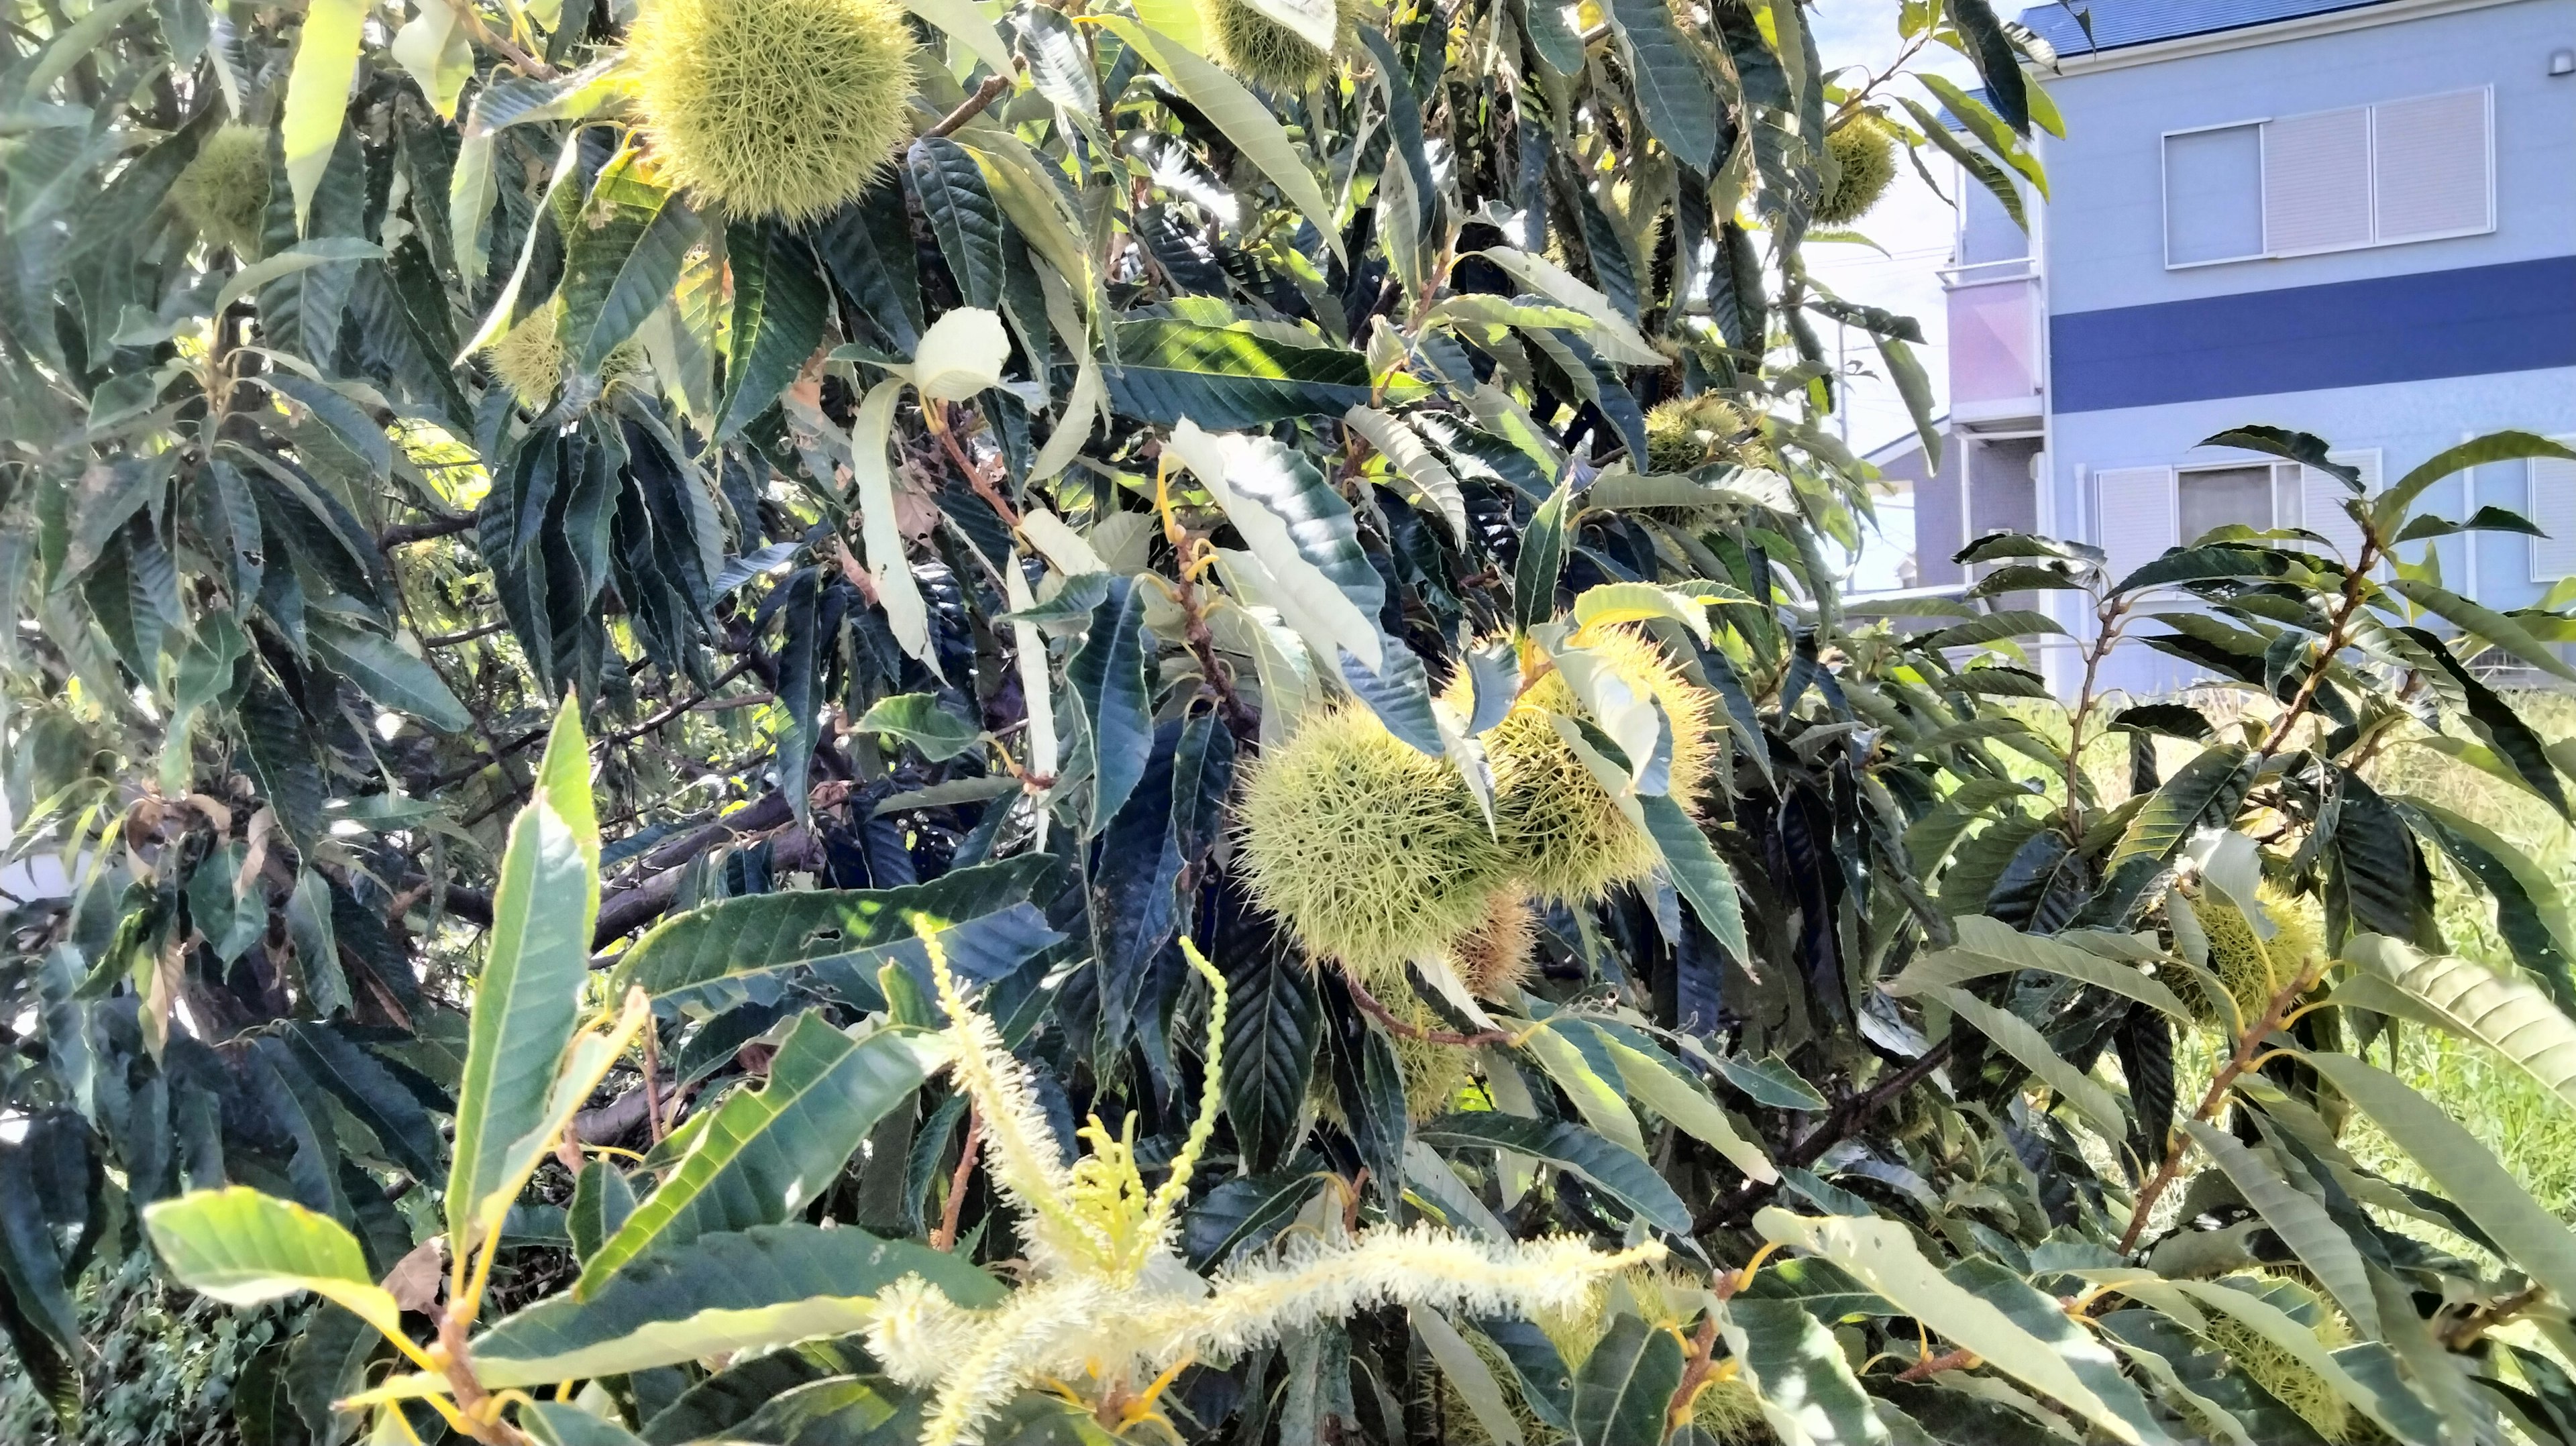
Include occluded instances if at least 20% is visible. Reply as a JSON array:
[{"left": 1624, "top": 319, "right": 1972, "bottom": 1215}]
[{"left": 1886, "top": 0, "right": 2576, "bottom": 691}]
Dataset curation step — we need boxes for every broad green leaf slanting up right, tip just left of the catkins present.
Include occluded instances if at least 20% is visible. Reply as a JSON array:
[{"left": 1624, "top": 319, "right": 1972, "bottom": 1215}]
[{"left": 574, "top": 1011, "right": 930, "bottom": 1299}]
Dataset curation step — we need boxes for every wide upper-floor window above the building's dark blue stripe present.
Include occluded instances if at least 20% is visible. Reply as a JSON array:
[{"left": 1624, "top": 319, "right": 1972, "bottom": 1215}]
[{"left": 2164, "top": 88, "right": 2496, "bottom": 268}]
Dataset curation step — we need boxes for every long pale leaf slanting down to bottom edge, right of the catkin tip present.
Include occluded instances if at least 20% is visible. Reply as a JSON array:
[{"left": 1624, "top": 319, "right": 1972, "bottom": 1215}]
[{"left": 1754, "top": 1207, "right": 2146, "bottom": 1446}]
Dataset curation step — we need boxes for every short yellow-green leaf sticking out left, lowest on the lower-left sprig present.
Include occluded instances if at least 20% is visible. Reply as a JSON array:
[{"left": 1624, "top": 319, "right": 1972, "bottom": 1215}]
[{"left": 144, "top": 1186, "right": 402, "bottom": 1335}]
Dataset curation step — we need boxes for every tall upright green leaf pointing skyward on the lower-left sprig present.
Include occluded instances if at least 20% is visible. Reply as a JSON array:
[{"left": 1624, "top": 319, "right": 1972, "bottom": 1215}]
[{"left": 445, "top": 696, "right": 600, "bottom": 1256}]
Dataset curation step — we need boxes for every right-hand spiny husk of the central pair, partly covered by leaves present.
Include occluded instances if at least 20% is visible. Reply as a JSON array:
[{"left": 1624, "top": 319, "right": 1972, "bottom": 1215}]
[{"left": 1484, "top": 626, "right": 1715, "bottom": 902}]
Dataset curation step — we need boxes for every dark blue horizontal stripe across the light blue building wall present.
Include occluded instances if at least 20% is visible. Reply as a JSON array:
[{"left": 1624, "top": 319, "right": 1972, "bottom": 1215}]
[{"left": 2048, "top": 255, "right": 2576, "bottom": 412}]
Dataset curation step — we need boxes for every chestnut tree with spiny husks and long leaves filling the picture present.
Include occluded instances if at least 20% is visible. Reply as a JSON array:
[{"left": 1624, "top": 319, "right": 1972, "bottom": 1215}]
[{"left": 0, "top": 0, "right": 2576, "bottom": 1446}]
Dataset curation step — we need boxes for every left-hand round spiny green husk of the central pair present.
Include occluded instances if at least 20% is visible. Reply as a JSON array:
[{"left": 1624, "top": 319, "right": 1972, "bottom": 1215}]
[{"left": 1236, "top": 706, "right": 1507, "bottom": 997}]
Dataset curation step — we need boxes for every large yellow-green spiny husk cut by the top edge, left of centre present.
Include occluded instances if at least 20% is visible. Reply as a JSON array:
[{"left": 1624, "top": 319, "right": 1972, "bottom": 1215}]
[{"left": 626, "top": 0, "right": 920, "bottom": 222}]
